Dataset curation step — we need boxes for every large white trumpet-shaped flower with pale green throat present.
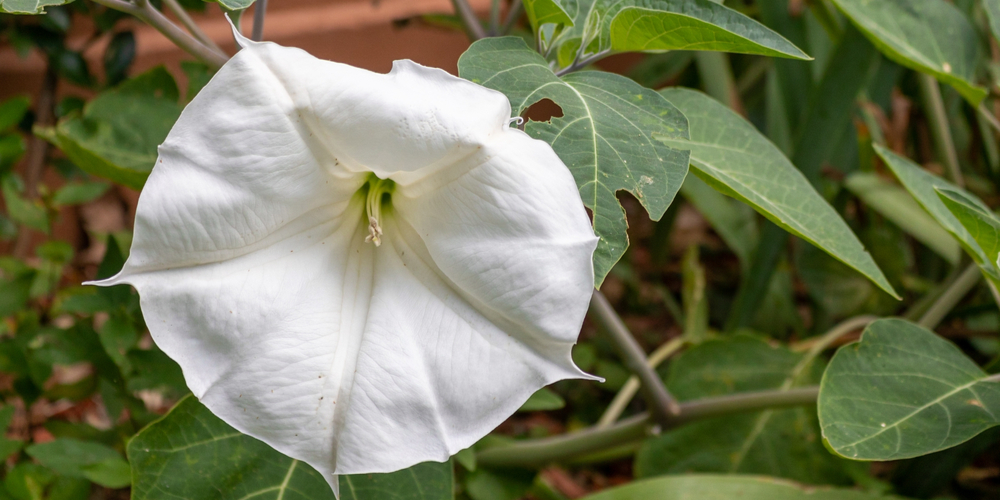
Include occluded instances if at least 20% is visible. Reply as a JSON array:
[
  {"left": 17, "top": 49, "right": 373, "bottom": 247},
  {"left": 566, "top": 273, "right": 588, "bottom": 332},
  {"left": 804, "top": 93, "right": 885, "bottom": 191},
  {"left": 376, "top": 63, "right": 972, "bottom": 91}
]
[{"left": 88, "top": 29, "right": 597, "bottom": 485}]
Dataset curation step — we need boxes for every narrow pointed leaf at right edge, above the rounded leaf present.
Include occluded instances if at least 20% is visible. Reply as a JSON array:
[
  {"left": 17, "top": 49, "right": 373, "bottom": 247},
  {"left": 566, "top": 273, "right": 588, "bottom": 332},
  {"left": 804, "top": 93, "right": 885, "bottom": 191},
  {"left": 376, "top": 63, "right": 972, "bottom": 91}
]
[{"left": 874, "top": 144, "right": 996, "bottom": 280}]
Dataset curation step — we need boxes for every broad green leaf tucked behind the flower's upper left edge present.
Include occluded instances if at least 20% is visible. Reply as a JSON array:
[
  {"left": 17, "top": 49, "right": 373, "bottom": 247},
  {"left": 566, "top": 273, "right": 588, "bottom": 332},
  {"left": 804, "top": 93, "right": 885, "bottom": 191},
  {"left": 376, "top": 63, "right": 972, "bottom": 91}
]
[{"left": 37, "top": 67, "right": 181, "bottom": 189}]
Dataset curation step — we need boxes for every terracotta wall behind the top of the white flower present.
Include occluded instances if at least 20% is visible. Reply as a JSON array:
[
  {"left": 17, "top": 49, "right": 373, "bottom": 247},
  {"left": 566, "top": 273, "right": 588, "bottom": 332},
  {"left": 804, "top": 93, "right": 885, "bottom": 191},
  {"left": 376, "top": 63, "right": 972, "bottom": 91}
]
[{"left": 0, "top": 0, "right": 489, "bottom": 99}]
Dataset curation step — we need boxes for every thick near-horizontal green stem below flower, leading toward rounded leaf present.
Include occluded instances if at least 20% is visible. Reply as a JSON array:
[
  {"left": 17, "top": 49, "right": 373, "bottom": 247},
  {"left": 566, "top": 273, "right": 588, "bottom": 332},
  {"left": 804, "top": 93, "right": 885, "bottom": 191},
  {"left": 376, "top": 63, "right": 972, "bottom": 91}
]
[{"left": 476, "top": 386, "right": 819, "bottom": 467}]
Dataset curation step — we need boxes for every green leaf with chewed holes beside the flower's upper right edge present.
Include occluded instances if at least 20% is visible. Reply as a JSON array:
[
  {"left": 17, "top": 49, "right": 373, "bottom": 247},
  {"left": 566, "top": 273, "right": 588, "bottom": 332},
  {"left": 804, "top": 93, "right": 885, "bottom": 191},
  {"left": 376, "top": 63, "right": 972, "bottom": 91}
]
[{"left": 458, "top": 37, "right": 688, "bottom": 285}]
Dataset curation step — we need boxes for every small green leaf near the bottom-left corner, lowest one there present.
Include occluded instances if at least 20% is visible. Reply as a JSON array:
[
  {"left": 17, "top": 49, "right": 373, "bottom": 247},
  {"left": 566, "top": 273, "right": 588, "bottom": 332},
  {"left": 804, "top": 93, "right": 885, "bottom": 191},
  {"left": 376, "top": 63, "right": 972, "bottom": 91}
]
[{"left": 24, "top": 438, "right": 131, "bottom": 488}]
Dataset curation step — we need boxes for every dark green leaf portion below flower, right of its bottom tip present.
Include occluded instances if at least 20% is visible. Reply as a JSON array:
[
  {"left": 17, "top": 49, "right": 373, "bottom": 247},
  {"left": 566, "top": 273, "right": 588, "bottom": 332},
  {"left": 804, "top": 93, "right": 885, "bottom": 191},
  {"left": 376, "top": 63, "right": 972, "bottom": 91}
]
[{"left": 340, "top": 462, "right": 454, "bottom": 500}]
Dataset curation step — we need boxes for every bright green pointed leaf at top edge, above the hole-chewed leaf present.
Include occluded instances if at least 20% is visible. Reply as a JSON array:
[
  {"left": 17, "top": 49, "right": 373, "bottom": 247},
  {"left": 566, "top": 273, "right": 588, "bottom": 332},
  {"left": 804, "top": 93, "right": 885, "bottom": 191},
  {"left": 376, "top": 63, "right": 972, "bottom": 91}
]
[{"left": 609, "top": 0, "right": 812, "bottom": 60}]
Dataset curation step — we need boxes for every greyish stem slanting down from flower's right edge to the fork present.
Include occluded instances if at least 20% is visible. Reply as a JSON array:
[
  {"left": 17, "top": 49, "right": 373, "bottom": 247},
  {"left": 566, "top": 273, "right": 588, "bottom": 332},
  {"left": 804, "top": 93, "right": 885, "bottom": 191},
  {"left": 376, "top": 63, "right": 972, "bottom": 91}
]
[{"left": 590, "top": 290, "right": 680, "bottom": 426}]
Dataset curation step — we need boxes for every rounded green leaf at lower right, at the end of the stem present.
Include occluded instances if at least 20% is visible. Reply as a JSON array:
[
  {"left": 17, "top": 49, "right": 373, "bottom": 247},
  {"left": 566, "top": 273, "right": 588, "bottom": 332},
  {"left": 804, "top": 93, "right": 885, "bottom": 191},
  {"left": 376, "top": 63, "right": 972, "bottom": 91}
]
[{"left": 819, "top": 319, "right": 1000, "bottom": 460}]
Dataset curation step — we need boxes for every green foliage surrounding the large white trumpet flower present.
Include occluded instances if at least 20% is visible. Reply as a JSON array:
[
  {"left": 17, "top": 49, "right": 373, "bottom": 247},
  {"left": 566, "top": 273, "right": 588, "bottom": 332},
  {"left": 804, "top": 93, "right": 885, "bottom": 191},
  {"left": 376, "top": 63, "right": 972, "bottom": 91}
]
[{"left": 0, "top": 0, "right": 1000, "bottom": 500}]
